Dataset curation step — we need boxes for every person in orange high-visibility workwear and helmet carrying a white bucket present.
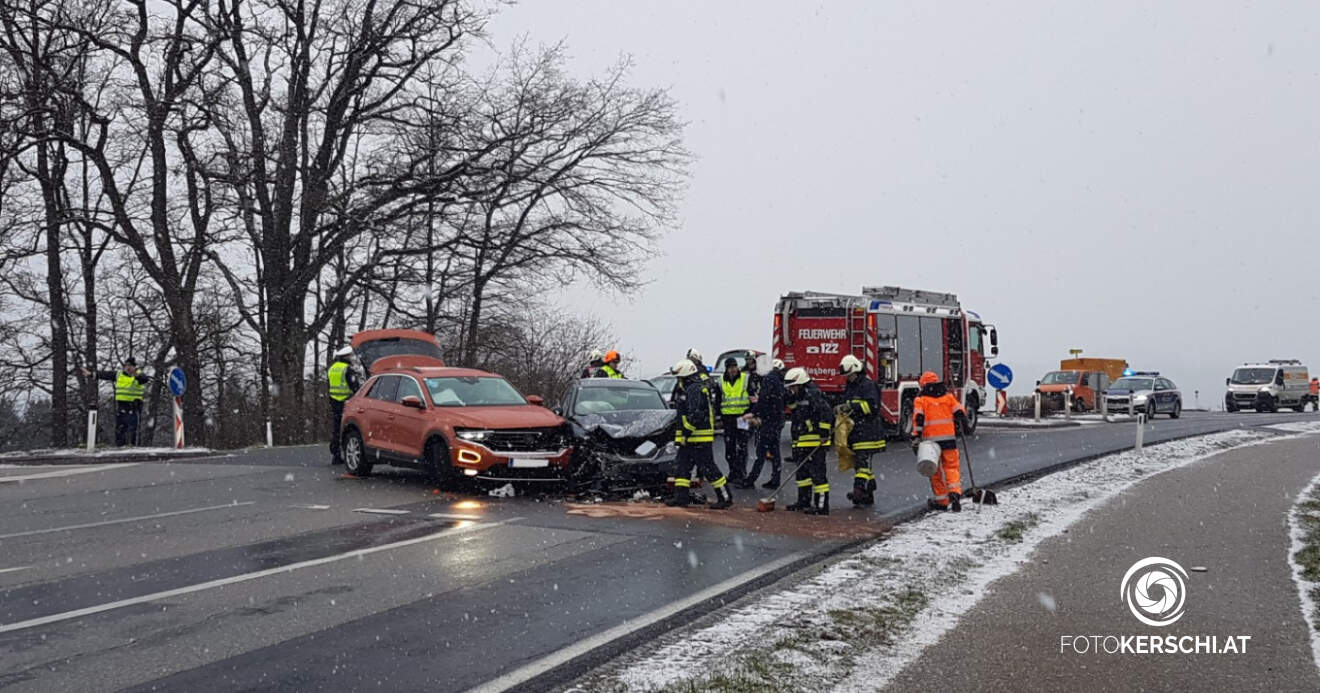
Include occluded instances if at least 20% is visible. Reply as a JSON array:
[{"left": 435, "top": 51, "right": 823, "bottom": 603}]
[{"left": 912, "top": 371, "right": 968, "bottom": 512}]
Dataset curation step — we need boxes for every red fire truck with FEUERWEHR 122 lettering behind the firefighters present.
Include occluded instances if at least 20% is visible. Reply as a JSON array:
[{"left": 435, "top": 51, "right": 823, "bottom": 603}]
[{"left": 772, "top": 286, "right": 999, "bottom": 437}]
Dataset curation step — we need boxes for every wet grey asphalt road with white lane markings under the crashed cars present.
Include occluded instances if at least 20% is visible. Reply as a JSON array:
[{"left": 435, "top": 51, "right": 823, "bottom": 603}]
[{"left": 0, "top": 413, "right": 1316, "bottom": 690}]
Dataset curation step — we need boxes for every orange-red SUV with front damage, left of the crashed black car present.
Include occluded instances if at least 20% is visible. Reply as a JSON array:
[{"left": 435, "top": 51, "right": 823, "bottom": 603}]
[{"left": 342, "top": 367, "right": 573, "bottom": 482}]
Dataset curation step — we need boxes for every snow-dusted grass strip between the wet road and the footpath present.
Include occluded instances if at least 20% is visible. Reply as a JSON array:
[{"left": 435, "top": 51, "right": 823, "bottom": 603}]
[{"left": 579, "top": 422, "right": 1320, "bottom": 692}]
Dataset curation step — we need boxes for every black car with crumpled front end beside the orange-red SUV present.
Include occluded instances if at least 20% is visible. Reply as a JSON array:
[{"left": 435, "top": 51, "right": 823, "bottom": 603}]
[{"left": 557, "top": 379, "right": 678, "bottom": 491}]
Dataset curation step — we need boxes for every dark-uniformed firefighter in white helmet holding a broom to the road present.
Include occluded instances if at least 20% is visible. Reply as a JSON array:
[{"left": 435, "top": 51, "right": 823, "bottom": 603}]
[{"left": 784, "top": 368, "right": 834, "bottom": 515}]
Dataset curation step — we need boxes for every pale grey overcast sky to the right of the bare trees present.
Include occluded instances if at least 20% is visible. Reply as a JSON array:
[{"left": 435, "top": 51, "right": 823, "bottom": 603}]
[{"left": 491, "top": 0, "right": 1320, "bottom": 405}]
